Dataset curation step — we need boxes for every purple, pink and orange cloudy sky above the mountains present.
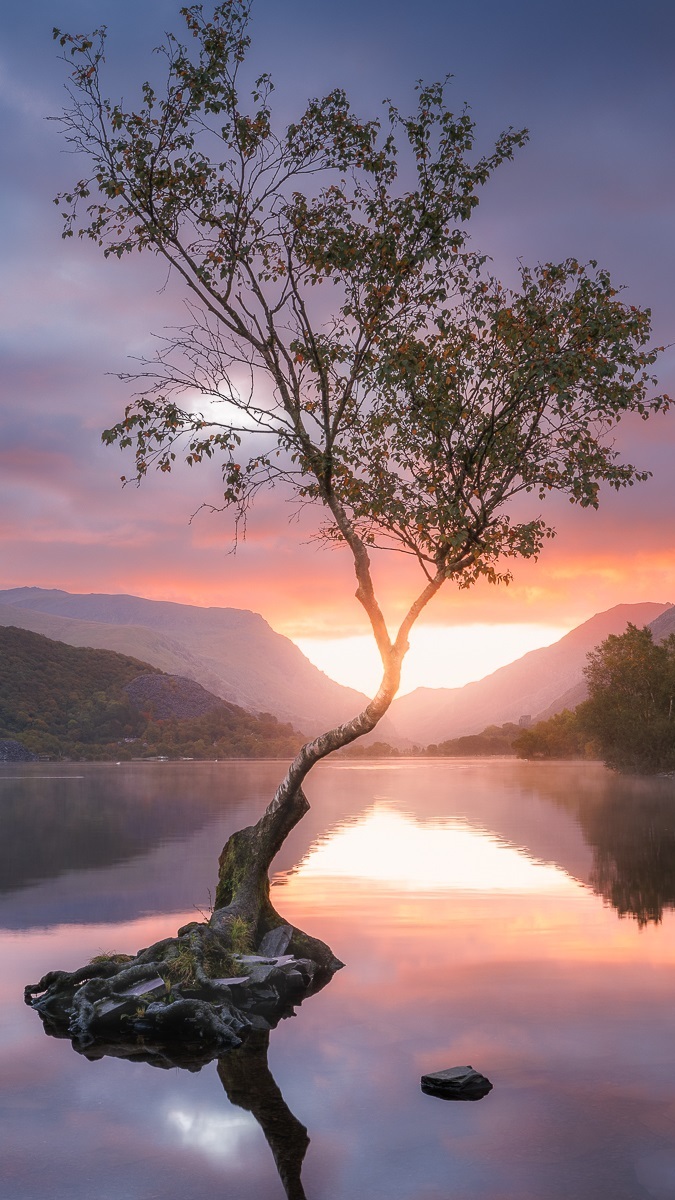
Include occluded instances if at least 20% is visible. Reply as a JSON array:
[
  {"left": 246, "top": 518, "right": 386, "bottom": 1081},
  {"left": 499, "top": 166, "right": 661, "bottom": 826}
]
[{"left": 0, "top": 0, "right": 675, "bottom": 689}]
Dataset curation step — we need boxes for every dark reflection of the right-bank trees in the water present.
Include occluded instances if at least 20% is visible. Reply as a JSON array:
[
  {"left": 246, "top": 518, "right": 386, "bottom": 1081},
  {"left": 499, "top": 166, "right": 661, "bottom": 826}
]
[{"left": 528, "top": 772, "right": 675, "bottom": 926}]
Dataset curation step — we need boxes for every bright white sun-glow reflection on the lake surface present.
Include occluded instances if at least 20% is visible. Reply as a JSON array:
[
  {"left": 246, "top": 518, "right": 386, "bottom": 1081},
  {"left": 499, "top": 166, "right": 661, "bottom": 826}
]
[{"left": 289, "top": 804, "right": 580, "bottom": 894}]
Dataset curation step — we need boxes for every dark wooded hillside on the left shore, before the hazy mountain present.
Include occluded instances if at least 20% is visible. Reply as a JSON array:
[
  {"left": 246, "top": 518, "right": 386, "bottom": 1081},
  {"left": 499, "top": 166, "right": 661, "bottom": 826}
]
[{"left": 0, "top": 626, "right": 303, "bottom": 760}]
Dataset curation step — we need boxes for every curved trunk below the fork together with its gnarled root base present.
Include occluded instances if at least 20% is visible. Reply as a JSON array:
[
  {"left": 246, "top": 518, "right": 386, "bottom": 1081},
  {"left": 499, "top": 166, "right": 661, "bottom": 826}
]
[{"left": 25, "top": 654, "right": 402, "bottom": 1049}]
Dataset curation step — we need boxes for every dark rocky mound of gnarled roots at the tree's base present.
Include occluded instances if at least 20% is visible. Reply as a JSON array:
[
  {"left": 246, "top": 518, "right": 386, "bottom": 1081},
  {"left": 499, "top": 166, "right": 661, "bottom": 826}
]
[{"left": 24, "top": 922, "right": 342, "bottom": 1069}]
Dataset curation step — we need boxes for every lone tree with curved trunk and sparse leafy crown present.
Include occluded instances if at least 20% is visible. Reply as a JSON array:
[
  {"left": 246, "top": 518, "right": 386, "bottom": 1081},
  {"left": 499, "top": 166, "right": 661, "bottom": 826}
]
[{"left": 27, "top": 0, "right": 669, "bottom": 1036}]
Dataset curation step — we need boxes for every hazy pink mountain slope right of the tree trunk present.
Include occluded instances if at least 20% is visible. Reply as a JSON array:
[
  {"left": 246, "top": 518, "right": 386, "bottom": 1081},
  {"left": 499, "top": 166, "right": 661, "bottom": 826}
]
[{"left": 392, "top": 604, "right": 675, "bottom": 745}]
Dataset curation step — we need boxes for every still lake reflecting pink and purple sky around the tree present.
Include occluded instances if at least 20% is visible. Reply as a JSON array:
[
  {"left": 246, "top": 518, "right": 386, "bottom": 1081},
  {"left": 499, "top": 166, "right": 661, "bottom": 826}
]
[{"left": 0, "top": 760, "right": 675, "bottom": 1200}]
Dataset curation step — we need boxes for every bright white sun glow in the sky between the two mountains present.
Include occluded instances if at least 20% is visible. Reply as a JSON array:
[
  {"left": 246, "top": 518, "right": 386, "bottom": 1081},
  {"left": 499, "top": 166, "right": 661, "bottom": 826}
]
[{"left": 293, "top": 624, "right": 569, "bottom": 696}]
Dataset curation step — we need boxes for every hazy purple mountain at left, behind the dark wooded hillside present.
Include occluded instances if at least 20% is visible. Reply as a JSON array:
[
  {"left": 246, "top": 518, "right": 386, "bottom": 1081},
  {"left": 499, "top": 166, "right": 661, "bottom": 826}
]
[{"left": 0, "top": 588, "right": 396, "bottom": 740}]
